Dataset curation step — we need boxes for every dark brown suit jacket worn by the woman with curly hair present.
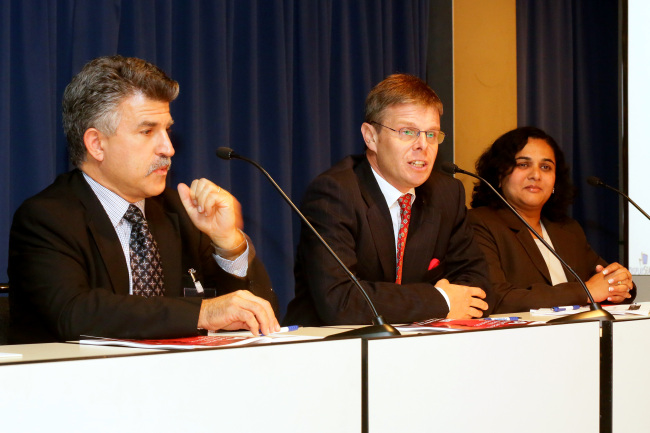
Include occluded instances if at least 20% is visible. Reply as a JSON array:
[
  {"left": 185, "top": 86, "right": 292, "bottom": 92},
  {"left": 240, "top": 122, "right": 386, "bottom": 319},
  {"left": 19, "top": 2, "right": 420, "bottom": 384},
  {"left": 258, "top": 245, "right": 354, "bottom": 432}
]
[{"left": 468, "top": 207, "right": 636, "bottom": 313}]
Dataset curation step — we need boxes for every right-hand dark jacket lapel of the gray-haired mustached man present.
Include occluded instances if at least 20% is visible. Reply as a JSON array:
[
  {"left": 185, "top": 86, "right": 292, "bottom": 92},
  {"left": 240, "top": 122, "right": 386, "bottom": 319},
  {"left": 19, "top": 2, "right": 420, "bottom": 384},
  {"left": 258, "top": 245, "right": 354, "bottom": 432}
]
[{"left": 145, "top": 198, "right": 183, "bottom": 296}]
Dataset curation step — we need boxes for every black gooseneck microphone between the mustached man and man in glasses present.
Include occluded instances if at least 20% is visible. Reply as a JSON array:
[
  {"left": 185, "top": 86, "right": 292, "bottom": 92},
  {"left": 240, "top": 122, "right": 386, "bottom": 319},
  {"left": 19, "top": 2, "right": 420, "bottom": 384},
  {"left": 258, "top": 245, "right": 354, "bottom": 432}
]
[{"left": 217, "top": 147, "right": 401, "bottom": 339}]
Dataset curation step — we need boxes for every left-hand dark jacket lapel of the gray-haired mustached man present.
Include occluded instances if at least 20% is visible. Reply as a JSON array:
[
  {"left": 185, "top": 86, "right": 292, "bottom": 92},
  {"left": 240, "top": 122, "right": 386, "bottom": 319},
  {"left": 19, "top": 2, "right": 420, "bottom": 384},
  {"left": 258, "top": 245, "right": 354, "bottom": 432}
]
[{"left": 72, "top": 171, "right": 129, "bottom": 295}]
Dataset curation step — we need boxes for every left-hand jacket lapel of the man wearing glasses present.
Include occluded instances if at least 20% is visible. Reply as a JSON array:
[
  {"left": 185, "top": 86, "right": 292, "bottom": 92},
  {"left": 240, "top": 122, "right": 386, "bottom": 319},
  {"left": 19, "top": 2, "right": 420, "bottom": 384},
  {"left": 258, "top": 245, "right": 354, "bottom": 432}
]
[{"left": 355, "top": 158, "right": 397, "bottom": 281}]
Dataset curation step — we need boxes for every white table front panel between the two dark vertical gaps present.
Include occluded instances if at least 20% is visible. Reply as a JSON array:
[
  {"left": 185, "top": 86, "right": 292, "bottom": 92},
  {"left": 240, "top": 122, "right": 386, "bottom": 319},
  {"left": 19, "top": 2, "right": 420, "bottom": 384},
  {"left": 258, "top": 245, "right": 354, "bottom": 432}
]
[{"left": 368, "top": 322, "right": 600, "bottom": 433}]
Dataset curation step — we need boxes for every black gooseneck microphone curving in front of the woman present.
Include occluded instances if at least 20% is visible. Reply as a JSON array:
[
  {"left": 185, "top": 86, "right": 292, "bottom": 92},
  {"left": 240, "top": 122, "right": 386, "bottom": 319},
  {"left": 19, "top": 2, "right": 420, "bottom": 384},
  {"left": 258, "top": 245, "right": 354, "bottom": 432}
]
[{"left": 442, "top": 162, "right": 615, "bottom": 323}]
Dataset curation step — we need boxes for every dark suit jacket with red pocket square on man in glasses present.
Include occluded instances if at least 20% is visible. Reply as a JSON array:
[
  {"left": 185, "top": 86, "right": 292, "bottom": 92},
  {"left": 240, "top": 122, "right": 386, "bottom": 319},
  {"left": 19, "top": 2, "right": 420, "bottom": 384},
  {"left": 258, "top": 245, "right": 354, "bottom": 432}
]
[{"left": 284, "top": 155, "right": 489, "bottom": 326}]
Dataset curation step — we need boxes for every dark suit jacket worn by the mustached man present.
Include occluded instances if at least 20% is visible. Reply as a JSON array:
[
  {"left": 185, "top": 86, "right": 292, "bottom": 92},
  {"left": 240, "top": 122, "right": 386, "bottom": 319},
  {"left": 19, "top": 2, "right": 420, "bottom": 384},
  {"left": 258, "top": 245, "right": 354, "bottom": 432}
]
[{"left": 8, "top": 170, "right": 277, "bottom": 343}]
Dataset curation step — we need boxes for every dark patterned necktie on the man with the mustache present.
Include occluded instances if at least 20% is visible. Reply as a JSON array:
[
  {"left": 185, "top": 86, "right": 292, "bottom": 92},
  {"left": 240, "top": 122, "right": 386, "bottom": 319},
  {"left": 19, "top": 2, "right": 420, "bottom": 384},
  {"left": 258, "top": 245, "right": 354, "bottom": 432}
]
[{"left": 124, "top": 204, "right": 165, "bottom": 298}]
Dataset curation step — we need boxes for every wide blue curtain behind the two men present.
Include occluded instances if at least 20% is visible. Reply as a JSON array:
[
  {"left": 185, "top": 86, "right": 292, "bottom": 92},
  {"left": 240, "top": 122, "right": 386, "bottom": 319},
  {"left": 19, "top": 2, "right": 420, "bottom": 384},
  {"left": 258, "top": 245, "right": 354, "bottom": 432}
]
[{"left": 0, "top": 0, "right": 429, "bottom": 318}]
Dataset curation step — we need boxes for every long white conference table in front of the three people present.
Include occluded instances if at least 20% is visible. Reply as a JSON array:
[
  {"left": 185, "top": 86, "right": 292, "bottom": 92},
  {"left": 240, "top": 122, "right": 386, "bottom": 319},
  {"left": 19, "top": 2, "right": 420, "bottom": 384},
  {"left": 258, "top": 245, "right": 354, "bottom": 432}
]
[{"left": 0, "top": 314, "right": 650, "bottom": 433}]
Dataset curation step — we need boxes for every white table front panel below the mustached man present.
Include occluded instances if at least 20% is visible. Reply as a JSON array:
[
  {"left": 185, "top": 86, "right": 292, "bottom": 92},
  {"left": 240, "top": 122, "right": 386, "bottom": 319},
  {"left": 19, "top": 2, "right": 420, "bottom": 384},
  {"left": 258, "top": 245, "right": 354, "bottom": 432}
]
[{"left": 0, "top": 340, "right": 361, "bottom": 433}]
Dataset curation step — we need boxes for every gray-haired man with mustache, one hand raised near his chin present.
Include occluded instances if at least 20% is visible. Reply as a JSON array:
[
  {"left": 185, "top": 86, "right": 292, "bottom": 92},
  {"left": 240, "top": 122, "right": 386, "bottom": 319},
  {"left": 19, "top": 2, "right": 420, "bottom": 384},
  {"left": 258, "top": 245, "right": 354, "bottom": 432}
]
[{"left": 8, "top": 56, "right": 280, "bottom": 344}]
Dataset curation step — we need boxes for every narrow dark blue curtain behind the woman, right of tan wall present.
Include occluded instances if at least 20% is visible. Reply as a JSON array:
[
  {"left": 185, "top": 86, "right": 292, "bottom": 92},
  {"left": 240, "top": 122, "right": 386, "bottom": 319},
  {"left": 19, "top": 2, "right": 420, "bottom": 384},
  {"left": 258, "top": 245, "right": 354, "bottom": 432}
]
[{"left": 517, "top": 0, "right": 623, "bottom": 263}]
